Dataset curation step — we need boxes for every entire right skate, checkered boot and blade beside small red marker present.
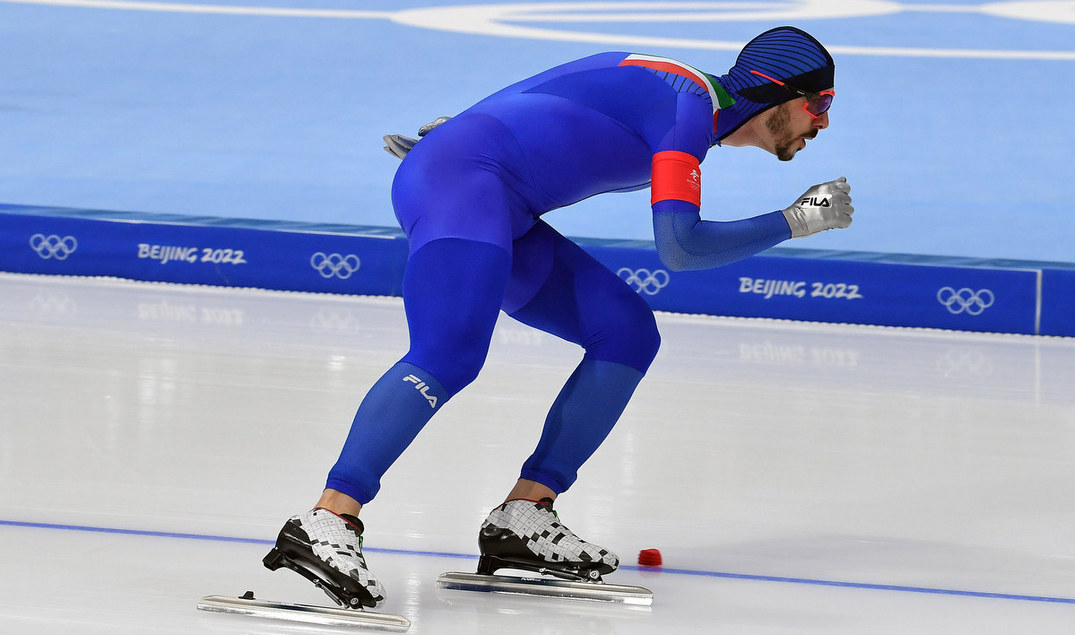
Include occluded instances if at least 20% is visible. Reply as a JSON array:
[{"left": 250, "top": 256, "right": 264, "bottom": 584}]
[{"left": 438, "top": 499, "right": 653, "bottom": 605}]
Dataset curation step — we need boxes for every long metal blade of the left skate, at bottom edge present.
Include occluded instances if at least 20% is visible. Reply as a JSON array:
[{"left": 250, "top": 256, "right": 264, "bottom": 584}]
[{"left": 198, "top": 595, "right": 411, "bottom": 631}]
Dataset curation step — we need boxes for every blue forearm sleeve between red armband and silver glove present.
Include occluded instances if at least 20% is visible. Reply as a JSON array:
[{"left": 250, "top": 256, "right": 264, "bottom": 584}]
[{"left": 654, "top": 201, "right": 791, "bottom": 271}]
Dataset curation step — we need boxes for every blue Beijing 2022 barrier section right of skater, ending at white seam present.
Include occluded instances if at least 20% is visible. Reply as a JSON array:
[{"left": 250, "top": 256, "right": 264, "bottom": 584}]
[{"left": 591, "top": 241, "right": 1038, "bottom": 333}]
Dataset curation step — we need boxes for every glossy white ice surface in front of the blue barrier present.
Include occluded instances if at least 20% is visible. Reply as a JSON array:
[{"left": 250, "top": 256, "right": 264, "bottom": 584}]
[{"left": 0, "top": 274, "right": 1075, "bottom": 635}]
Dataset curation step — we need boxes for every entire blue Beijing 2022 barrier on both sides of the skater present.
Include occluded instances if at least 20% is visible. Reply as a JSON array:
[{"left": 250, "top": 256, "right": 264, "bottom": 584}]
[{"left": 0, "top": 204, "right": 1075, "bottom": 336}]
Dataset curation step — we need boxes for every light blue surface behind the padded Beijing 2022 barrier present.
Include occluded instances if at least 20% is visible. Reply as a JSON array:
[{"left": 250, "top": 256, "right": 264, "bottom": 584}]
[{"left": 0, "top": 0, "right": 1075, "bottom": 261}]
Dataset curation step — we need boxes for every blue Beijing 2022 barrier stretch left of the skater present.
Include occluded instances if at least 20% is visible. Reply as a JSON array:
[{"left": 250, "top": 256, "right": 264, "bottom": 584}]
[{"left": 0, "top": 205, "right": 407, "bottom": 295}]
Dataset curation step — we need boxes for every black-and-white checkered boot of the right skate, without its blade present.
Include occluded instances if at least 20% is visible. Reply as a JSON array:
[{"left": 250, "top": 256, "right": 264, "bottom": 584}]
[{"left": 478, "top": 499, "right": 619, "bottom": 574}]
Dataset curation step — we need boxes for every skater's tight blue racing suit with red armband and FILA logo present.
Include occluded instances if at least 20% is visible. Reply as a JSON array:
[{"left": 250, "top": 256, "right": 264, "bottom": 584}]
[{"left": 328, "top": 53, "right": 790, "bottom": 504}]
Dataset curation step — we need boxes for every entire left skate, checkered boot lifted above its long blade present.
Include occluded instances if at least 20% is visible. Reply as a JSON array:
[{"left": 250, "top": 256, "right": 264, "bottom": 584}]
[{"left": 198, "top": 508, "right": 411, "bottom": 630}]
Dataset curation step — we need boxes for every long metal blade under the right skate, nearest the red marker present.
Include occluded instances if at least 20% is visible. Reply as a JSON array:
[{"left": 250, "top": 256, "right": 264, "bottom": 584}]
[{"left": 436, "top": 572, "right": 654, "bottom": 606}]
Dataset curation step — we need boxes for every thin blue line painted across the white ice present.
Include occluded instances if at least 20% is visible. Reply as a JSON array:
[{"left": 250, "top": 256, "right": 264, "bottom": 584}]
[{"left": 0, "top": 520, "right": 1075, "bottom": 604}]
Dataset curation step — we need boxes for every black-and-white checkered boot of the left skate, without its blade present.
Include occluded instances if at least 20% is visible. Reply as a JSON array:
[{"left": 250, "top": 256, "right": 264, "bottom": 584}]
[{"left": 264, "top": 508, "right": 385, "bottom": 608}]
